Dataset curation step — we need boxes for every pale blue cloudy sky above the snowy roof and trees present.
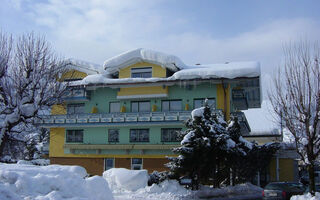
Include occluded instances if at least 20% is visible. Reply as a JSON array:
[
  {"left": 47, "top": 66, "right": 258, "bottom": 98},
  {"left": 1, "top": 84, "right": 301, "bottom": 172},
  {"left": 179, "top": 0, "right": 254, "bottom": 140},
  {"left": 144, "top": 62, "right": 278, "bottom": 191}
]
[{"left": 0, "top": 0, "right": 320, "bottom": 81}]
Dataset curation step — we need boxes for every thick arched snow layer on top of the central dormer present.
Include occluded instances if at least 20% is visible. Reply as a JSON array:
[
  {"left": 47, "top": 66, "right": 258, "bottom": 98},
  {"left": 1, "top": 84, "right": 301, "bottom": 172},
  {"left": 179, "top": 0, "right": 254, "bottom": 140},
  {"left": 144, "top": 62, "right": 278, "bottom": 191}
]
[{"left": 103, "top": 48, "right": 185, "bottom": 74}]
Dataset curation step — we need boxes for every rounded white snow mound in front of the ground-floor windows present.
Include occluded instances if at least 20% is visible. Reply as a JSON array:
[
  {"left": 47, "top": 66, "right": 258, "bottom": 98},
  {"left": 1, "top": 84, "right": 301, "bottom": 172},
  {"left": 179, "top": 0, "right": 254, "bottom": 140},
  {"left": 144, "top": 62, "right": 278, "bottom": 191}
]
[{"left": 103, "top": 168, "right": 149, "bottom": 192}]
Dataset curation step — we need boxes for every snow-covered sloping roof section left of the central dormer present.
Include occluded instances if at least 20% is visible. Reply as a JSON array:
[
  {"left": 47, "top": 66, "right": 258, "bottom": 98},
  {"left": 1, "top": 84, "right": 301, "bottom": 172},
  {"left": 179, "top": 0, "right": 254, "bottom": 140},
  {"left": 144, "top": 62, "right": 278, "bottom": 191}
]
[{"left": 66, "top": 58, "right": 103, "bottom": 75}]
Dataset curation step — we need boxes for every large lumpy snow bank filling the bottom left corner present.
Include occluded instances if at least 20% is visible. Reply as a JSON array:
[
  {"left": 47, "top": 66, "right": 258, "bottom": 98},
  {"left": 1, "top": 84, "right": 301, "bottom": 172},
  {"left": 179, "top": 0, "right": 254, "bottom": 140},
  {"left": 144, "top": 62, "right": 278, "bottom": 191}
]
[{"left": 0, "top": 164, "right": 113, "bottom": 200}]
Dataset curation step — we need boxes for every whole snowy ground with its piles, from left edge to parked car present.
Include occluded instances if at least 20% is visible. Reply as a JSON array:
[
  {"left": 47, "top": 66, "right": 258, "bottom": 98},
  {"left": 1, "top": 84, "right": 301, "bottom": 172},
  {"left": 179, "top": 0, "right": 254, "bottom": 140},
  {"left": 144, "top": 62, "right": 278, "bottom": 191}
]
[{"left": 0, "top": 162, "right": 262, "bottom": 200}]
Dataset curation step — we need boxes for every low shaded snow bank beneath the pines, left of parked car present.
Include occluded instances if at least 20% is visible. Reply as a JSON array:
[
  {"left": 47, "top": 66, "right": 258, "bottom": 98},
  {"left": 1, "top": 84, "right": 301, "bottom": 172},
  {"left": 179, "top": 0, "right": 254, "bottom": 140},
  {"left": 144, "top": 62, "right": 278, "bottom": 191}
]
[{"left": 196, "top": 183, "right": 263, "bottom": 199}]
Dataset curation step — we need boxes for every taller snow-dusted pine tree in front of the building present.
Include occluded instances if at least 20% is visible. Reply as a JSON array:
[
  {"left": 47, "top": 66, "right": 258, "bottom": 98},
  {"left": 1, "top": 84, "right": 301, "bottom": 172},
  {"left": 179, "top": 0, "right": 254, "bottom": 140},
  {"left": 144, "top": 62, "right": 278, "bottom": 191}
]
[{"left": 167, "top": 103, "right": 235, "bottom": 187}]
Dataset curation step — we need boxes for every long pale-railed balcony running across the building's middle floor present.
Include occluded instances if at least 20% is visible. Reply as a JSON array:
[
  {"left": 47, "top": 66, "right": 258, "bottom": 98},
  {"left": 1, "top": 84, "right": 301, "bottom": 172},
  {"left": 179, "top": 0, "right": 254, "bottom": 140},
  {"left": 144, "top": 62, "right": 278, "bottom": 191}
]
[{"left": 38, "top": 110, "right": 251, "bottom": 135}]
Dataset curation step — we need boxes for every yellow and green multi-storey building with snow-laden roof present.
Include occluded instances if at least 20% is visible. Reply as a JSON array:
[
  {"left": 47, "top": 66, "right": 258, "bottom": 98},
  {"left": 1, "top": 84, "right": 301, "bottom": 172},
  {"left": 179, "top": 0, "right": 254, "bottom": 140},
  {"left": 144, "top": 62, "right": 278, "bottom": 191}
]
[{"left": 41, "top": 49, "right": 261, "bottom": 175}]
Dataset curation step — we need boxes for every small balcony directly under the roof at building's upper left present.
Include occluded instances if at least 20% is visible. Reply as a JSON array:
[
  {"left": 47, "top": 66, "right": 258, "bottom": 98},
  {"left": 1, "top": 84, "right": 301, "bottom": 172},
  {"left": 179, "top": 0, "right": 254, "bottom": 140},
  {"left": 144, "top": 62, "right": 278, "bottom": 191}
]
[{"left": 63, "top": 87, "right": 90, "bottom": 102}]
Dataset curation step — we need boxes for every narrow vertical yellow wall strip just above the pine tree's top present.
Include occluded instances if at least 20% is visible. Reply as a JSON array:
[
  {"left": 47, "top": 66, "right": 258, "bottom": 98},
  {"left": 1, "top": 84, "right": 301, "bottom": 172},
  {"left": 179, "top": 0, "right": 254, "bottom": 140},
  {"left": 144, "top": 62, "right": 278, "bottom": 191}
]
[{"left": 217, "top": 84, "right": 230, "bottom": 120}]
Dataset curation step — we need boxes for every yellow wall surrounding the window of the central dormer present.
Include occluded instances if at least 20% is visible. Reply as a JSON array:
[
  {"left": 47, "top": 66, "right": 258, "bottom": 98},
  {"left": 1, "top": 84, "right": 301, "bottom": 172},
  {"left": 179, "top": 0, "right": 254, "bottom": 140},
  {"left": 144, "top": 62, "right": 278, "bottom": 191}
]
[{"left": 119, "top": 62, "right": 167, "bottom": 78}]
